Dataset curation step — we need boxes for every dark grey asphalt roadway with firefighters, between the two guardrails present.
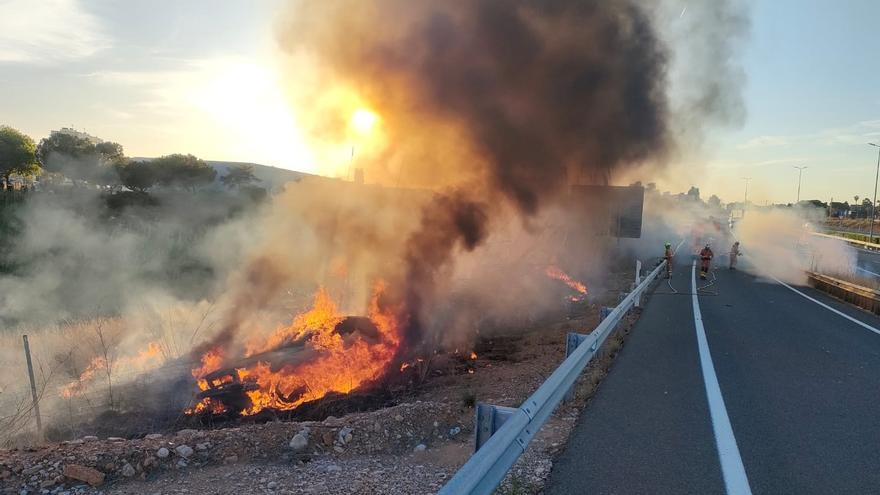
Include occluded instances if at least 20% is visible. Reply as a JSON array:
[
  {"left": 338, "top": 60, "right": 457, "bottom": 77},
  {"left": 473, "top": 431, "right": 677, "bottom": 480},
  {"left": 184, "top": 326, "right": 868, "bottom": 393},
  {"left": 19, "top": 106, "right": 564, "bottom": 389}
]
[{"left": 547, "top": 260, "right": 880, "bottom": 494}]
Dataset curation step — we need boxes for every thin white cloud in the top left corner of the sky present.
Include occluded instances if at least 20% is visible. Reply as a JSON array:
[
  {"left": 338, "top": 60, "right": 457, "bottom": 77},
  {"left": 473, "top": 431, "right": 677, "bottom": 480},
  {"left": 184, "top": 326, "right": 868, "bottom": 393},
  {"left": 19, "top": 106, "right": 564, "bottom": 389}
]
[{"left": 0, "top": 0, "right": 110, "bottom": 64}]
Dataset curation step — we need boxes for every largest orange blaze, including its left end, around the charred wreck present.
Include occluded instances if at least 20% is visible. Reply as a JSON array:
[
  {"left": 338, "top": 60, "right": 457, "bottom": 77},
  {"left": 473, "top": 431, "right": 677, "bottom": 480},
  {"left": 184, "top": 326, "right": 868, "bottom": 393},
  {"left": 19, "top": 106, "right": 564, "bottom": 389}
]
[{"left": 190, "top": 283, "right": 401, "bottom": 416}]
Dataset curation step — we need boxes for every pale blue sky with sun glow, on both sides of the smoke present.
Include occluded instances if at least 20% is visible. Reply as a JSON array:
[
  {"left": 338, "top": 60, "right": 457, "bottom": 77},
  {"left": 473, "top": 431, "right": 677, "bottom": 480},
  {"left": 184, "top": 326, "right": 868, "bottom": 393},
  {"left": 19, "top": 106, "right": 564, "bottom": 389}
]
[{"left": 0, "top": 0, "right": 880, "bottom": 203}]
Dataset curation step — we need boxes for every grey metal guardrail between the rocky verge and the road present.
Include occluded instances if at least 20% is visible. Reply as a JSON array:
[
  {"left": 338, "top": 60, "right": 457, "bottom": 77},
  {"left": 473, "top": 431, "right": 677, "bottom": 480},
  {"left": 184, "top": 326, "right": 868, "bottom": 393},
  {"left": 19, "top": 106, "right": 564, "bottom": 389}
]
[{"left": 438, "top": 260, "right": 666, "bottom": 495}]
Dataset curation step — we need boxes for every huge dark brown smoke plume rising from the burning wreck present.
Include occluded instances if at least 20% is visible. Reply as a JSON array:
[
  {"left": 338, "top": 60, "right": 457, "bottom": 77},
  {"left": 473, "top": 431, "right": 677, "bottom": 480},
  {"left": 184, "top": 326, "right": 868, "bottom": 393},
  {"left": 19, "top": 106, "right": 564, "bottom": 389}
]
[{"left": 280, "top": 0, "right": 670, "bottom": 348}]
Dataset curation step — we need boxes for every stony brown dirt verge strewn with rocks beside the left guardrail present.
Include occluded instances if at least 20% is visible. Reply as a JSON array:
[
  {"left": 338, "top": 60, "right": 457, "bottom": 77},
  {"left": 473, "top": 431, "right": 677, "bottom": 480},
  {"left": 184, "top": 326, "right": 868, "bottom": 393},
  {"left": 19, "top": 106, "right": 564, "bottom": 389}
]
[{"left": 0, "top": 272, "right": 637, "bottom": 495}]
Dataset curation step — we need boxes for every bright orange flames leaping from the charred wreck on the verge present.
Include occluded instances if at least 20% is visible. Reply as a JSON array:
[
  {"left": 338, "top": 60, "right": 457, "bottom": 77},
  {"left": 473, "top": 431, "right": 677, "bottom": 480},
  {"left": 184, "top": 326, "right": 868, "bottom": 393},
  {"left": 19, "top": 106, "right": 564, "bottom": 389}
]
[{"left": 193, "top": 283, "right": 400, "bottom": 416}]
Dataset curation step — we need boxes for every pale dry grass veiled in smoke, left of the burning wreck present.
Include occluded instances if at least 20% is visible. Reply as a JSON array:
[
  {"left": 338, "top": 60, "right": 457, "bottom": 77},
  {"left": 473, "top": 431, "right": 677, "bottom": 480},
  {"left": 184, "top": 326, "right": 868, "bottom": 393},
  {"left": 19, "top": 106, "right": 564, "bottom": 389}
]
[{"left": 0, "top": 303, "right": 214, "bottom": 447}]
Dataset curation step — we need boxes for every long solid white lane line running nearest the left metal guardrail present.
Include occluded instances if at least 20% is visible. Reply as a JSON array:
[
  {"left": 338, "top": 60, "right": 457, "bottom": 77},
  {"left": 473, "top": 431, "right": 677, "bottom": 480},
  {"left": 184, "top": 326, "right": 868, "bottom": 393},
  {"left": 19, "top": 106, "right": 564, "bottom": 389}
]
[{"left": 691, "top": 261, "right": 752, "bottom": 495}]
